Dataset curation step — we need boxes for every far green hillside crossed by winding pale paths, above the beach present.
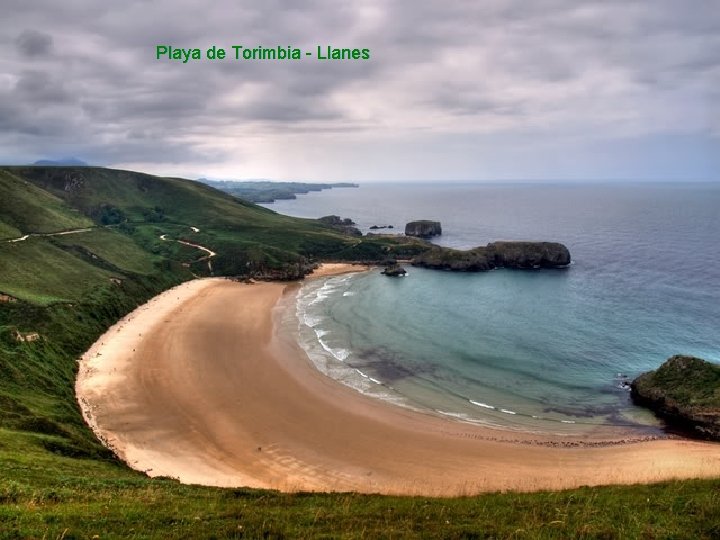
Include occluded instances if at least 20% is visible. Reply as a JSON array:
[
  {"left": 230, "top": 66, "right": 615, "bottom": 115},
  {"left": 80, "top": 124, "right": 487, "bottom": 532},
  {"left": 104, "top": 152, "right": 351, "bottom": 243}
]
[{"left": 0, "top": 167, "right": 424, "bottom": 303}]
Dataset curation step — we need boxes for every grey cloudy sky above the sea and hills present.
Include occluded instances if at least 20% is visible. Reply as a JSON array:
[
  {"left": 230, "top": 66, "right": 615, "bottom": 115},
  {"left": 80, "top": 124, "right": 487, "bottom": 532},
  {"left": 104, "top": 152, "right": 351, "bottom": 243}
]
[{"left": 0, "top": 0, "right": 720, "bottom": 181}]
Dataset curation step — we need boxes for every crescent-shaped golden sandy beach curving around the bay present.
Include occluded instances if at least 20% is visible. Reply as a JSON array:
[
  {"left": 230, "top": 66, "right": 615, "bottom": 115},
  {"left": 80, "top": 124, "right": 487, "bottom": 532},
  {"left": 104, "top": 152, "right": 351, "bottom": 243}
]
[{"left": 76, "top": 265, "right": 720, "bottom": 495}]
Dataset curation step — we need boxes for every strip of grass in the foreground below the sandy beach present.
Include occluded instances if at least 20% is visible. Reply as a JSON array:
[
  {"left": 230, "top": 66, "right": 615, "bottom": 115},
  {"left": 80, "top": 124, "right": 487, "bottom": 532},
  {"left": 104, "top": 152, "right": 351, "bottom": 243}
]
[{"left": 0, "top": 430, "right": 720, "bottom": 540}]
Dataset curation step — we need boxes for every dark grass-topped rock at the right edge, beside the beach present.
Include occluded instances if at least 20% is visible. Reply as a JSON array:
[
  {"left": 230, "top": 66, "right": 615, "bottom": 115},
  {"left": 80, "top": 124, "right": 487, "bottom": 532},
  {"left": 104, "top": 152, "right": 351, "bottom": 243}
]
[{"left": 630, "top": 355, "right": 720, "bottom": 441}]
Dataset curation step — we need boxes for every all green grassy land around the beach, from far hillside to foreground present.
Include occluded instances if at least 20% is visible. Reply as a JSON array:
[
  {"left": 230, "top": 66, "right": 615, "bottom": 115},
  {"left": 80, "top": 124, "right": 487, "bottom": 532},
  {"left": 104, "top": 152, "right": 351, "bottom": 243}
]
[{"left": 0, "top": 167, "right": 720, "bottom": 539}]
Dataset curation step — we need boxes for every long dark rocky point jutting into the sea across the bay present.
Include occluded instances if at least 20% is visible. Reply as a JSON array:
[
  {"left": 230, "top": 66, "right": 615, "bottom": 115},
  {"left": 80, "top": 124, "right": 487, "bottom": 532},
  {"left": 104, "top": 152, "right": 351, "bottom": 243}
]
[{"left": 412, "top": 242, "right": 571, "bottom": 272}]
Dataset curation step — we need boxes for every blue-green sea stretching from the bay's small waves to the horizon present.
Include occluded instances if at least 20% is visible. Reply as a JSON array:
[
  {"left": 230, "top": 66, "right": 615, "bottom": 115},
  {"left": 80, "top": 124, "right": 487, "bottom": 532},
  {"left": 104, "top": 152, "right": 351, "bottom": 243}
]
[{"left": 268, "top": 183, "right": 720, "bottom": 432}]
